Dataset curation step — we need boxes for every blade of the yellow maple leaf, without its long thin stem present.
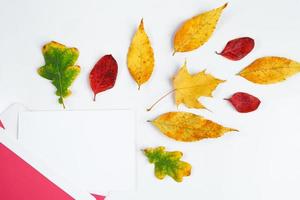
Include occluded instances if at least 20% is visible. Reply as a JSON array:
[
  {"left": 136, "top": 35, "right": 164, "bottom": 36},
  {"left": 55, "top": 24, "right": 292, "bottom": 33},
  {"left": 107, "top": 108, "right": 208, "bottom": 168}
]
[{"left": 173, "top": 62, "right": 224, "bottom": 108}]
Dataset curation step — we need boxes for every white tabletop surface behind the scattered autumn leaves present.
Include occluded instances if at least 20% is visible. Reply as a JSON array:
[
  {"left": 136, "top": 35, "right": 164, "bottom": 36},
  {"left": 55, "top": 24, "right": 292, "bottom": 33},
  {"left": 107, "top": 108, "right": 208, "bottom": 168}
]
[{"left": 0, "top": 0, "right": 300, "bottom": 200}]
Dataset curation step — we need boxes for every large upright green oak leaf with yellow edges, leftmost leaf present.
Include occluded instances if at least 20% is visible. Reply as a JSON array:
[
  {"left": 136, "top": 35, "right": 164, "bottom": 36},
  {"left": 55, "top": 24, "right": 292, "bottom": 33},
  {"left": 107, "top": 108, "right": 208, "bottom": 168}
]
[{"left": 38, "top": 41, "right": 80, "bottom": 108}]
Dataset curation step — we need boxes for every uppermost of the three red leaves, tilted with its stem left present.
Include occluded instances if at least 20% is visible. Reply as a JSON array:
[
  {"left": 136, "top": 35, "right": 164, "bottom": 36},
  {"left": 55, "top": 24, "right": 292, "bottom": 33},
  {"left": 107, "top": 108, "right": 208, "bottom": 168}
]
[{"left": 216, "top": 37, "right": 254, "bottom": 61}]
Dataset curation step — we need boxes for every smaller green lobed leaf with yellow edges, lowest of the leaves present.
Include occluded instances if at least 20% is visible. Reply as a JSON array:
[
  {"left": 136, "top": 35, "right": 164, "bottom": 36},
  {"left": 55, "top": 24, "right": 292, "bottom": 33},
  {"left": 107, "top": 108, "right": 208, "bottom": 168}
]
[{"left": 143, "top": 147, "right": 192, "bottom": 182}]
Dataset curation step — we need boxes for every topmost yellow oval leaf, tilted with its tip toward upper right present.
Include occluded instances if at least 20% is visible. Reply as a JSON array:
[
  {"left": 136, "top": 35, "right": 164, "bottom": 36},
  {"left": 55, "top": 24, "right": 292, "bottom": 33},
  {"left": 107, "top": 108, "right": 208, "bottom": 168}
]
[{"left": 174, "top": 3, "right": 227, "bottom": 53}]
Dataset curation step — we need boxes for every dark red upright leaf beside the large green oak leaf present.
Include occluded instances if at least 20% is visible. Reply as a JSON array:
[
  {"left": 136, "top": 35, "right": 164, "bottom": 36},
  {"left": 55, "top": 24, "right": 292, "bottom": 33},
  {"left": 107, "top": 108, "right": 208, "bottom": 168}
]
[{"left": 90, "top": 55, "right": 118, "bottom": 101}]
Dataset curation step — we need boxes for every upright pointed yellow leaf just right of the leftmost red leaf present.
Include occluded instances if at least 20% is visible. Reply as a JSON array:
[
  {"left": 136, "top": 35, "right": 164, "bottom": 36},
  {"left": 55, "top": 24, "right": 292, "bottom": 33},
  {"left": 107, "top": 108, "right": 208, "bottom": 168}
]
[{"left": 127, "top": 19, "right": 154, "bottom": 88}]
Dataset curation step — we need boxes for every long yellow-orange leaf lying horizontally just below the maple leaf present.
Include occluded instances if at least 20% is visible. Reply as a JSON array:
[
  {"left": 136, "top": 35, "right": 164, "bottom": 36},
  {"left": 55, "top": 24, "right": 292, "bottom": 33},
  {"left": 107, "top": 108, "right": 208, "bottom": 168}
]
[{"left": 151, "top": 112, "right": 237, "bottom": 142}]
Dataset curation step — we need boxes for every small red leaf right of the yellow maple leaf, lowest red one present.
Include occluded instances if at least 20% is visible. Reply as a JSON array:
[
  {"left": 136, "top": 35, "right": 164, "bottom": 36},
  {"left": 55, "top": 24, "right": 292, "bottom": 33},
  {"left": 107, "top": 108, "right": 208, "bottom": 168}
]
[{"left": 225, "top": 92, "right": 260, "bottom": 113}]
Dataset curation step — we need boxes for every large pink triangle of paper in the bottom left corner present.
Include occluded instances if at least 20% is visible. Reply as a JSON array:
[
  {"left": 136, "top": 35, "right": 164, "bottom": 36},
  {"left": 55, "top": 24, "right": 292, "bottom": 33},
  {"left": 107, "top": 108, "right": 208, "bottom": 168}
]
[{"left": 0, "top": 143, "right": 74, "bottom": 200}]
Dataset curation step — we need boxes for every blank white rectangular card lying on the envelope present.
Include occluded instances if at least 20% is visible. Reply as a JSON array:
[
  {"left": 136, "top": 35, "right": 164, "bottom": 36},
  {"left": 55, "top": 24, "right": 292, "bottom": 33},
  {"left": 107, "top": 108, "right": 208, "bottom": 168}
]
[{"left": 19, "top": 110, "right": 135, "bottom": 194}]
